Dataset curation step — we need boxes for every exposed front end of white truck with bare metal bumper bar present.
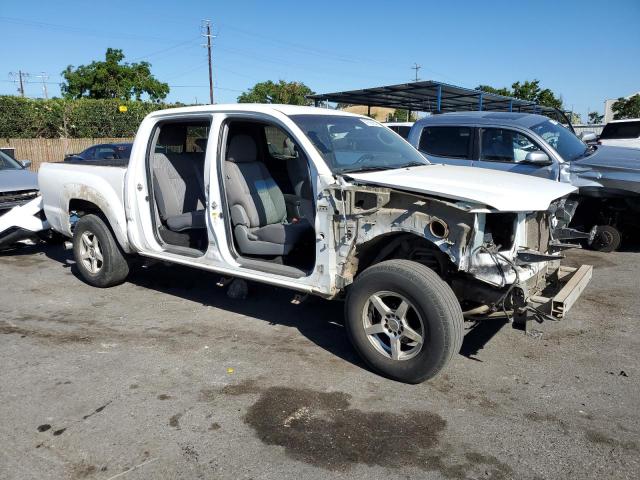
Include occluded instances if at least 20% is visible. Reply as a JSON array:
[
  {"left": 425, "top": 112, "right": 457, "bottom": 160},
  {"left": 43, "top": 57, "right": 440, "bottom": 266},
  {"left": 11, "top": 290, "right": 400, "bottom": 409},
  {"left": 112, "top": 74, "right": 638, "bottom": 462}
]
[{"left": 452, "top": 199, "right": 592, "bottom": 326}]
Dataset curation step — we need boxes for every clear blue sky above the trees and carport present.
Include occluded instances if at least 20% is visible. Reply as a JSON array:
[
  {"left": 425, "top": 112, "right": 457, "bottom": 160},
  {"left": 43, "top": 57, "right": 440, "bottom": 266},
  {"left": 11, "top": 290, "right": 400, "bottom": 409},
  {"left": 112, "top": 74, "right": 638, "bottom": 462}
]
[{"left": 0, "top": 0, "right": 640, "bottom": 118}]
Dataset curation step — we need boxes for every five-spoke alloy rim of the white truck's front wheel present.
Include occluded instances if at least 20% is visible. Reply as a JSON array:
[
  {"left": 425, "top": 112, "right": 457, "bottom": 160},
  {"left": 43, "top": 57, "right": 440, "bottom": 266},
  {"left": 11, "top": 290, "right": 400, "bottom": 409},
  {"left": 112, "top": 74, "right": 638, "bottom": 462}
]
[{"left": 362, "top": 291, "right": 426, "bottom": 361}]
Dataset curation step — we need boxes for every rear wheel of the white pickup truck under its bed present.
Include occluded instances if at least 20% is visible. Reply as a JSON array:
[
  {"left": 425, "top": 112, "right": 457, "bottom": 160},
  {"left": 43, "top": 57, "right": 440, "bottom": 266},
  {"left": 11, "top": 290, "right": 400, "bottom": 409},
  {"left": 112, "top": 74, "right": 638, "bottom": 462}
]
[{"left": 73, "top": 214, "right": 129, "bottom": 288}]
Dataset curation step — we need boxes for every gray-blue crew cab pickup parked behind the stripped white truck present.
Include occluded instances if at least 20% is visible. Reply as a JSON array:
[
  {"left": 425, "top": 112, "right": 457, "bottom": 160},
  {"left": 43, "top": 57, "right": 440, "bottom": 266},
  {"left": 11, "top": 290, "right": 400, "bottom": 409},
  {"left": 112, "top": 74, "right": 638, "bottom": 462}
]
[{"left": 409, "top": 112, "right": 640, "bottom": 251}]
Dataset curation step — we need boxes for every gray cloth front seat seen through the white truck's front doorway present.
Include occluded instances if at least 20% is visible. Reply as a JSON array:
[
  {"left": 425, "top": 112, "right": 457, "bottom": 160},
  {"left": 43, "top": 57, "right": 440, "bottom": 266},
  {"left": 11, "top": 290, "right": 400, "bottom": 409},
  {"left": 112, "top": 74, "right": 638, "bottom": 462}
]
[{"left": 225, "top": 134, "right": 313, "bottom": 256}]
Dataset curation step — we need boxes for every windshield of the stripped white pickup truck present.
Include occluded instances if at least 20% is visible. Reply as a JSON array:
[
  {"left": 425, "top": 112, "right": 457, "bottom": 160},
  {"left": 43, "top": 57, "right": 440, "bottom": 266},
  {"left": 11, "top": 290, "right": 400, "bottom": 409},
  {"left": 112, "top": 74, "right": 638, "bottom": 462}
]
[{"left": 291, "top": 115, "right": 429, "bottom": 173}]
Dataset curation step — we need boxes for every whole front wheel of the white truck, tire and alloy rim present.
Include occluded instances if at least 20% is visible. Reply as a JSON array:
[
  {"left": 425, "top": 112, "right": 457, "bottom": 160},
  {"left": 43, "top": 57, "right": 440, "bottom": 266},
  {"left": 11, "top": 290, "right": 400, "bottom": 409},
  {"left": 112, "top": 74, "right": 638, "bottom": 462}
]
[{"left": 345, "top": 260, "right": 464, "bottom": 383}]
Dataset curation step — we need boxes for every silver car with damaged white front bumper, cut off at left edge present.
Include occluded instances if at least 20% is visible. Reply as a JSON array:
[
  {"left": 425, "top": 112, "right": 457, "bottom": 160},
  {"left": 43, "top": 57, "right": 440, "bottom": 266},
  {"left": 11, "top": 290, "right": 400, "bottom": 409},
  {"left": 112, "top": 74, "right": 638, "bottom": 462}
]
[{"left": 0, "top": 152, "right": 49, "bottom": 249}]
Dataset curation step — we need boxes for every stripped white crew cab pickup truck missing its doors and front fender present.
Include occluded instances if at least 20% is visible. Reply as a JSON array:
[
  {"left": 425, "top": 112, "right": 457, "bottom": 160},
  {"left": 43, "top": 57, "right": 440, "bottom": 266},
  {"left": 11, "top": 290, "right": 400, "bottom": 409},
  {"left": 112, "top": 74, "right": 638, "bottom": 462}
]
[{"left": 39, "top": 104, "right": 591, "bottom": 383}]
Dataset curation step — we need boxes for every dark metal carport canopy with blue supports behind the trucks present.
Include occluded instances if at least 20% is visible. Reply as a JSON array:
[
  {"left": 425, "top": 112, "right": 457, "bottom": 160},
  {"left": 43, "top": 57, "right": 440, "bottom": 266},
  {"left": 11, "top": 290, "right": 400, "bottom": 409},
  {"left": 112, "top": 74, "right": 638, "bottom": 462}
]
[{"left": 307, "top": 80, "right": 570, "bottom": 124}]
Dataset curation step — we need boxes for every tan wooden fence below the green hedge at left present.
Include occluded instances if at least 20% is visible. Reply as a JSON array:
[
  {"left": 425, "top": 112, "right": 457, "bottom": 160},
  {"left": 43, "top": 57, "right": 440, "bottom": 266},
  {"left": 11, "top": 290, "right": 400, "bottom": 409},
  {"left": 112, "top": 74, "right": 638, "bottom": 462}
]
[{"left": 0, "top": 138, "right": 133, "bottom": 172}]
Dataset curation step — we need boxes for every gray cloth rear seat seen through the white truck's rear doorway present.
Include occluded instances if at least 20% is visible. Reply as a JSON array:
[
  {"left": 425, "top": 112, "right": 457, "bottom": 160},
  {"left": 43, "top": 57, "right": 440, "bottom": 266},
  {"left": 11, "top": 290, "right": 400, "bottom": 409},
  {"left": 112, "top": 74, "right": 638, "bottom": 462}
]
[{"left": 153, "top": 152, "right": 206, "bottom": 232}]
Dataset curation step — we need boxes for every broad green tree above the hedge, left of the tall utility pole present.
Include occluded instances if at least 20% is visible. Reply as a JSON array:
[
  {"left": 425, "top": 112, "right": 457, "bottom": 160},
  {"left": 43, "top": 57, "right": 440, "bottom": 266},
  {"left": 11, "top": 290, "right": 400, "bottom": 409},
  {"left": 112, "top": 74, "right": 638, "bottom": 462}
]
[{"left": 60, "top": 48, "right": 169, "bottom": 101}]
